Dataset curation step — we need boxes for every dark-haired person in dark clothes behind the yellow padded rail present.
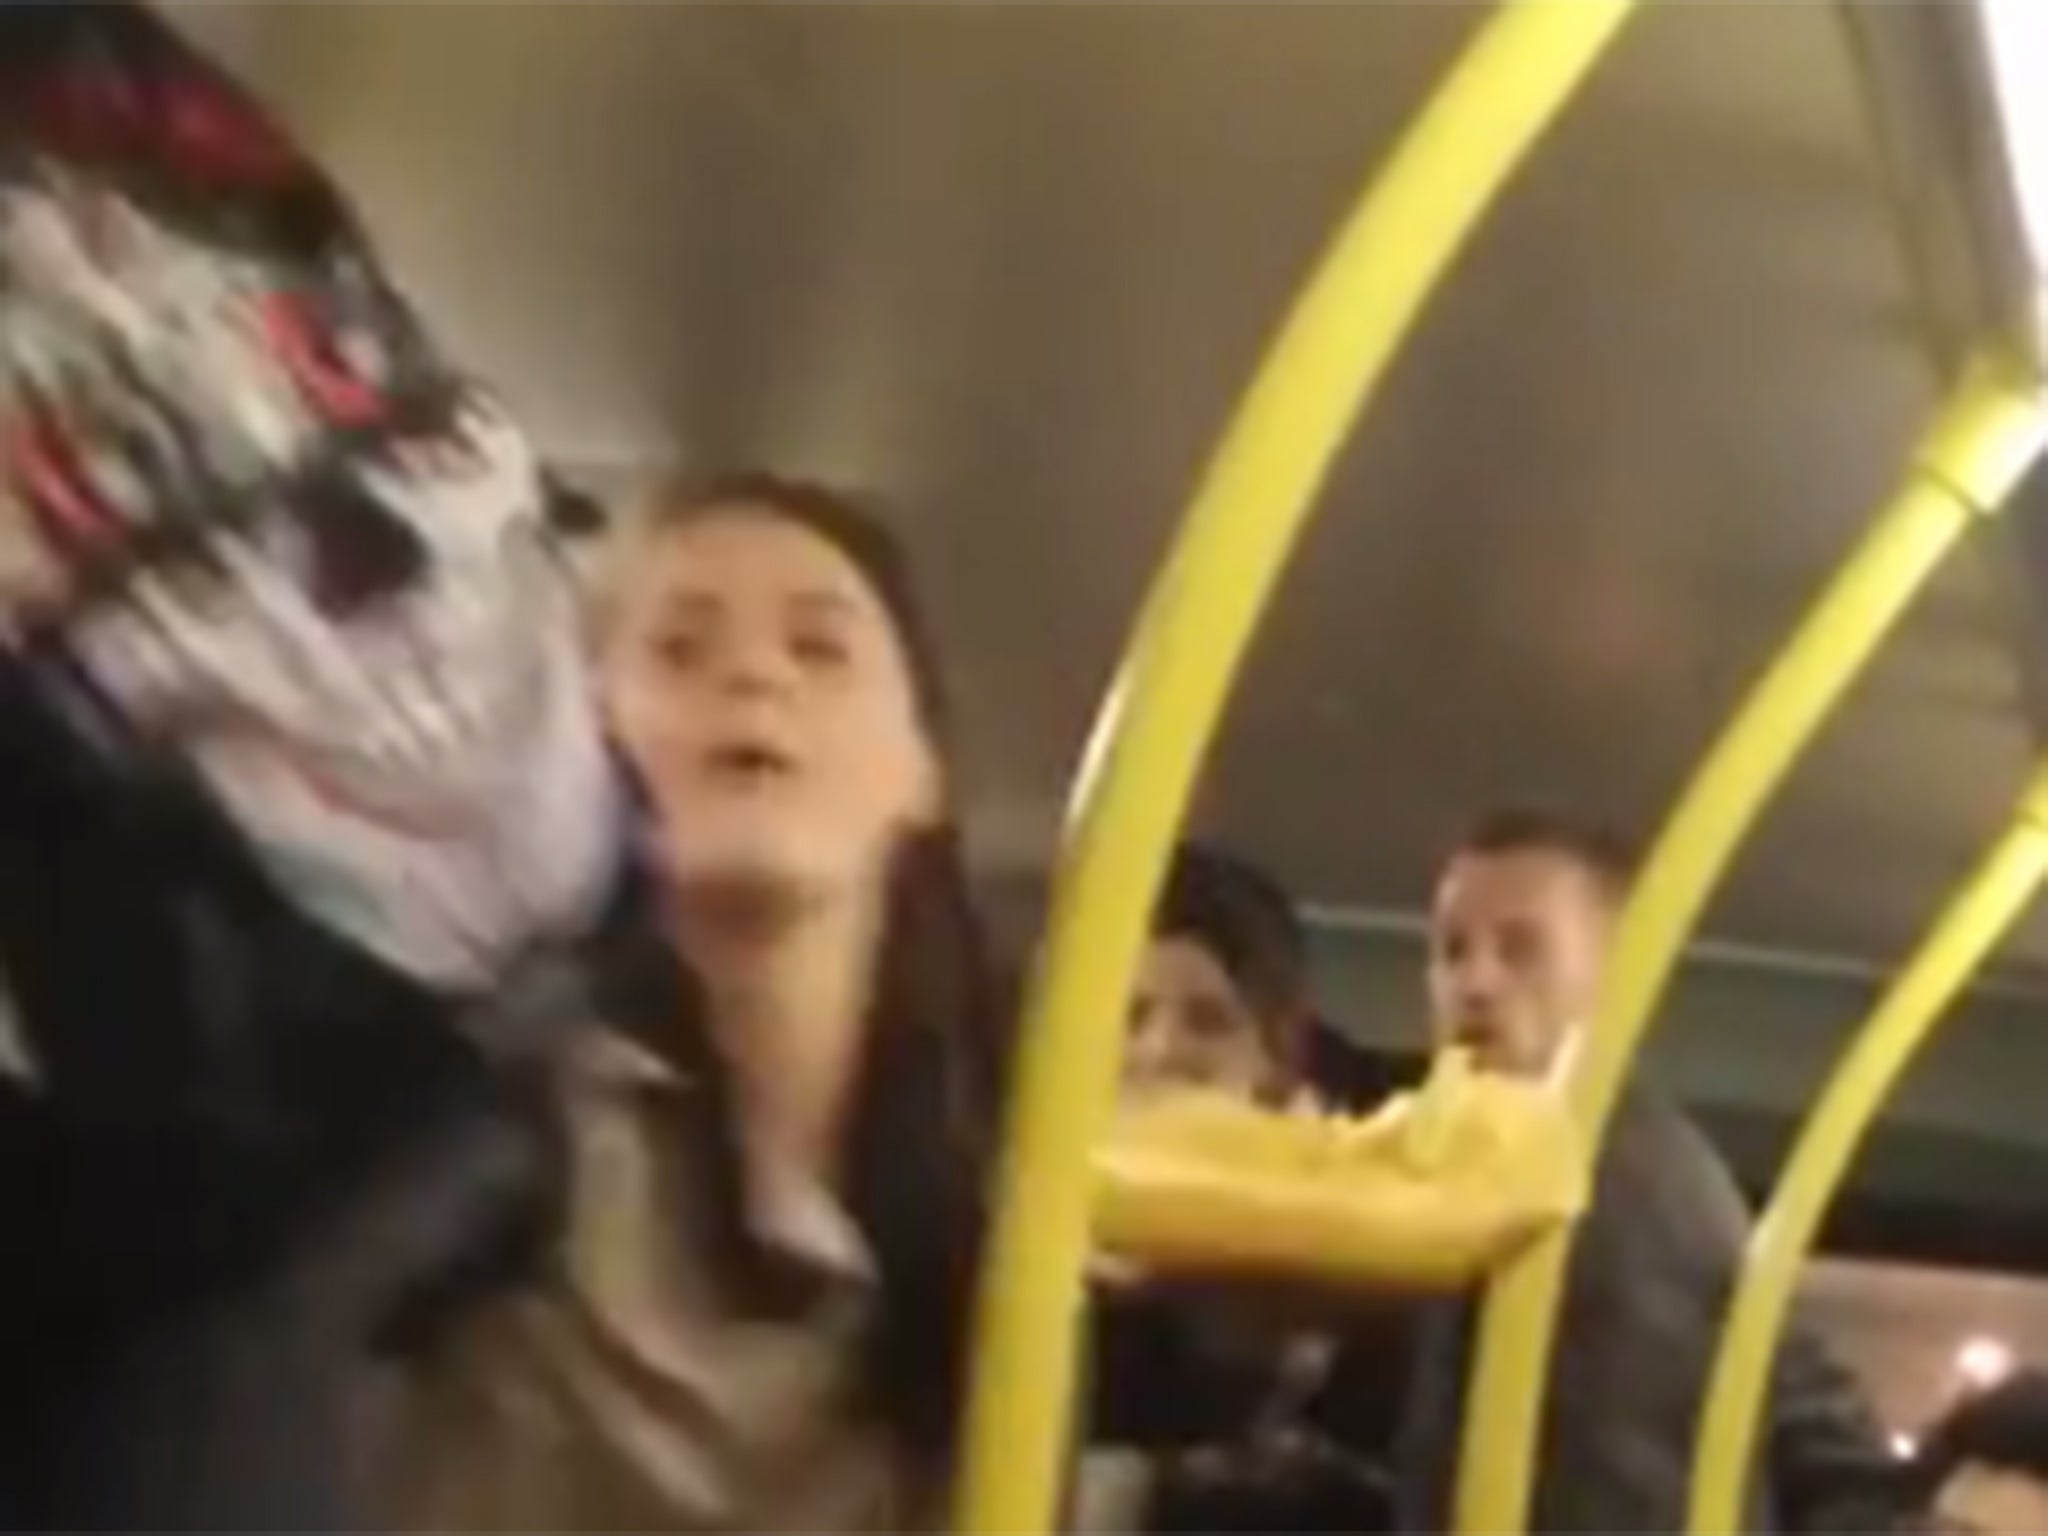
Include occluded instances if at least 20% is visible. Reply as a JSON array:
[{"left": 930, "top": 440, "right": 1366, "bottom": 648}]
[{"left": 1083, "top": 848, "right": 1399, "bottom": 1532}]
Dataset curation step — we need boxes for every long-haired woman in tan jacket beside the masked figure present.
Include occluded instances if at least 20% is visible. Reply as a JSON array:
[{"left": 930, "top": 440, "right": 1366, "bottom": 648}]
[{"left": 393, "top": 477, "right": 993, "bottom": 1532}]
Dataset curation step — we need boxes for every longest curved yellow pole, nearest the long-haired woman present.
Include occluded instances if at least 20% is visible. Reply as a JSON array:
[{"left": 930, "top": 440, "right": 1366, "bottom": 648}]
[{"left": 956, "top": 0, "right": 1632, "bottom": 1536}]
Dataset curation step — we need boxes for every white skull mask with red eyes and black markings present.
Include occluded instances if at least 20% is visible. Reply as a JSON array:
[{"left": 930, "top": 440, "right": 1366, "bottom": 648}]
[{"left": 0, "top": 4, "right": 614, "bottom": 987}]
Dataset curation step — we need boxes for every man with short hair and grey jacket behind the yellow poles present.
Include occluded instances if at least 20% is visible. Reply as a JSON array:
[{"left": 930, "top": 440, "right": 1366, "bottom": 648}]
[{"left": 1399, "top": 811, "right": 1896, "bottom": 1532}]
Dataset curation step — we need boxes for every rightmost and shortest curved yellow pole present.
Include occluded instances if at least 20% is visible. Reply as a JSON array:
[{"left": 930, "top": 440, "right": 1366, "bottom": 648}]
[{"left": 1688, "top": 766, "right": 2048, "bottom": 1536}]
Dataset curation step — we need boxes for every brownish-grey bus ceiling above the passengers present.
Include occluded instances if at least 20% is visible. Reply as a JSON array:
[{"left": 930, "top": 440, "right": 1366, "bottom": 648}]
[{"left": 144, "top": 0, "right": 2048, "bottom": 987}]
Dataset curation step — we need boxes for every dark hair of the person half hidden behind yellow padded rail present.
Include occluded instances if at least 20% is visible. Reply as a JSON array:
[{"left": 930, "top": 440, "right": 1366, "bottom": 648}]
[{"left": 1153, "top": 842, "right": 1309, "bottom": 1067}]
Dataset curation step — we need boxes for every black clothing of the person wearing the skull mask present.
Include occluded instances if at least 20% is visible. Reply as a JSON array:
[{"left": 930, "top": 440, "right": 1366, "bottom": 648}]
[{"left": 0, "top": 666, "right": 561, "bottom": 1530}]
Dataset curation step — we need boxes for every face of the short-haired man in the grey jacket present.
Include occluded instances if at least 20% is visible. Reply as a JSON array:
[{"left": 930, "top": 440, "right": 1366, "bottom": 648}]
[{"left": 1430, "top": 848, "right": 1612, "bottom": 1077}]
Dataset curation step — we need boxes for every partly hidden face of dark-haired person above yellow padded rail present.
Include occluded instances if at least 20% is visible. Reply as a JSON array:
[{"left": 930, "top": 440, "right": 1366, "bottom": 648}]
[{"left": 1124, "top": 938, "right": 1280, "bottom": 1098}]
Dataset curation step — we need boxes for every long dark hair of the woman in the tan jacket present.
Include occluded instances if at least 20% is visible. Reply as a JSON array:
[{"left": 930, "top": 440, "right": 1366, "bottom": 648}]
[{"left": 604, "top": 473, "right": 1004, "bottom": 1454}]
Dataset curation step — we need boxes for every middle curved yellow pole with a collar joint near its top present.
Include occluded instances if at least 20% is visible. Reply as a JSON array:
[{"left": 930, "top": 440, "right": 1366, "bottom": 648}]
[{"left": 1456, "top": 362, "right": 2044, "bottom": 1536}]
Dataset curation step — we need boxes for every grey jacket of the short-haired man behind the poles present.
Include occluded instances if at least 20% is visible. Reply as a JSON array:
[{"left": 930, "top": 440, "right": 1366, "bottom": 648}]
[{"left": 1399, "top": 1094, "right": 1892, "bottom": 1532}]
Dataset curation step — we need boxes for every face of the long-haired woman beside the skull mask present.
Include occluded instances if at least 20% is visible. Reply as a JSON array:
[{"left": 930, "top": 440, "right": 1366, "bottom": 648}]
[{"left": 604, "top": 506, "right": 940, "bottom": 899}]
